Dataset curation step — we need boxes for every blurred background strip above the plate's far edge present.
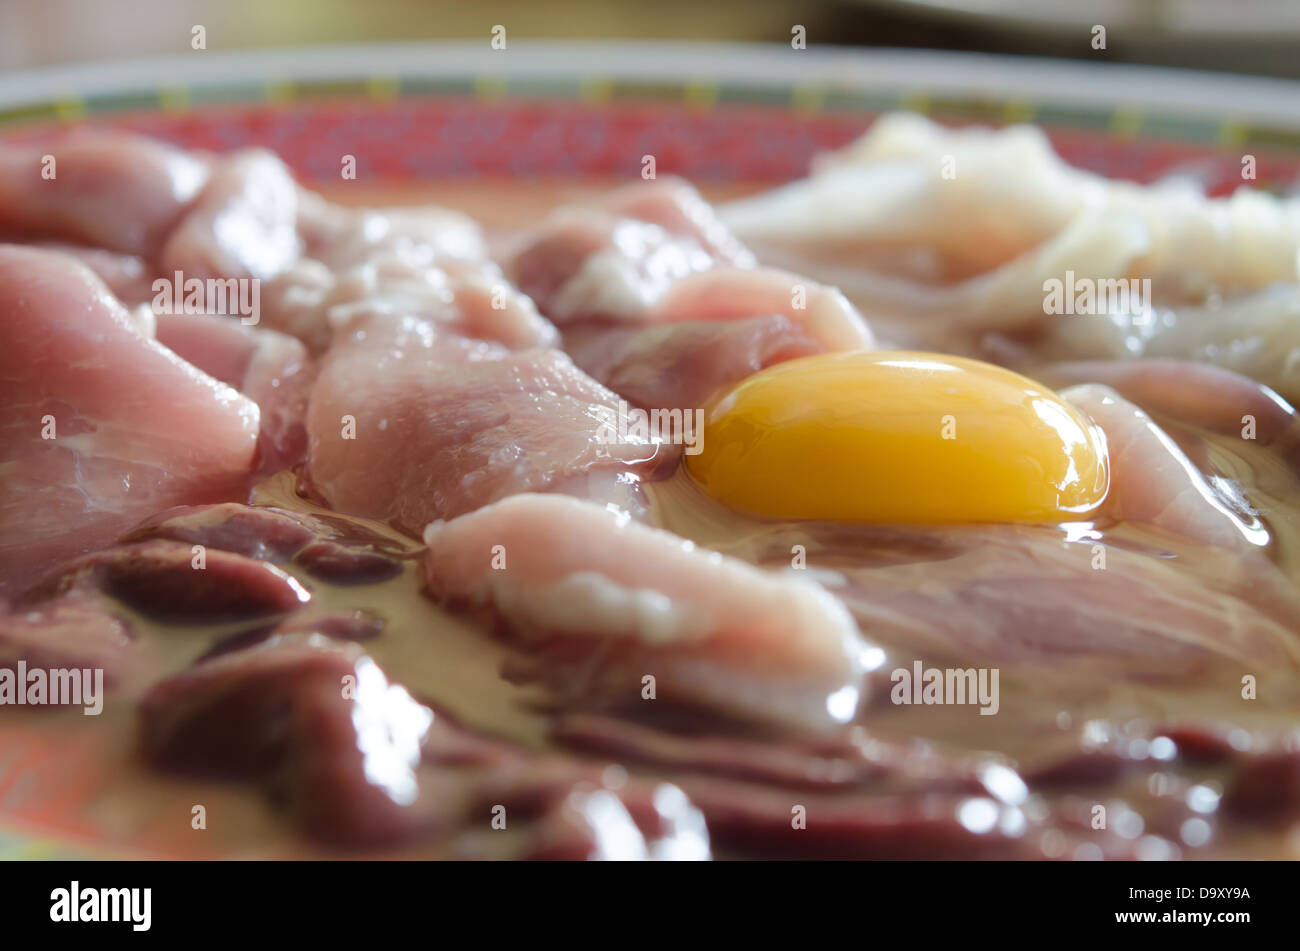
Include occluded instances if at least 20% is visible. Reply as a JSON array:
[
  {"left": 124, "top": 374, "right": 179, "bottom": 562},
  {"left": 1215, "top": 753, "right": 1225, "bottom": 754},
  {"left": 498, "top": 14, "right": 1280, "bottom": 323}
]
[{"left": 0, "top": 0, "right": 1300, "bottom": 77}]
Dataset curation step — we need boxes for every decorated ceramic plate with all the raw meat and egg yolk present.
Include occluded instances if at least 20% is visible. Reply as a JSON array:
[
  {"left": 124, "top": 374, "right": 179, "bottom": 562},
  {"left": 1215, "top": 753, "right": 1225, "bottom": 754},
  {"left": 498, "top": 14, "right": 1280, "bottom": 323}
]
[{"left": 0, "top": 43, "right": 1300, "bottom": 859}]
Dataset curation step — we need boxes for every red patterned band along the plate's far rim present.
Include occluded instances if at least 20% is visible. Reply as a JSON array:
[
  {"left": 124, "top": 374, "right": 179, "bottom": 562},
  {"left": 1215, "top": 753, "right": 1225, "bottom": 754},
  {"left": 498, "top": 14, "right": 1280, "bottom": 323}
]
[{"left": 0, "top": 97, "right": 1300, "bottom": 195}]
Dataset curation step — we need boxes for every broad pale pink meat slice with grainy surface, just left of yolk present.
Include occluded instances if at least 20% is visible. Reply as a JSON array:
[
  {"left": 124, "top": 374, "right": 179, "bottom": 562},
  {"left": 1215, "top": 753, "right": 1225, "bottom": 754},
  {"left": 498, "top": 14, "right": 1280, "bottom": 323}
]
[{"left": 307, "top": 311, "right": 676, "bottom": 535}]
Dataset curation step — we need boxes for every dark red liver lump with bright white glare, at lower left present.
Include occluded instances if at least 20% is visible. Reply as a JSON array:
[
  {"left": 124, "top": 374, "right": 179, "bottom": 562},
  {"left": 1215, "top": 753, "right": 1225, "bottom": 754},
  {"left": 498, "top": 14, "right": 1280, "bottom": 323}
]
[{"left": 140, "top": 635, "right": 447, "bottom": 847}]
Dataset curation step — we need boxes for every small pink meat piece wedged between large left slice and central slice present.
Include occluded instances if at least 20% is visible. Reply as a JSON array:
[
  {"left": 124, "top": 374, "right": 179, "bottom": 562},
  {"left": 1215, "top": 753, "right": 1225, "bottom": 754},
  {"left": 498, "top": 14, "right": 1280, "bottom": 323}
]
[{"left": 156, "top": 314, "right": 313, "bottom": 472}]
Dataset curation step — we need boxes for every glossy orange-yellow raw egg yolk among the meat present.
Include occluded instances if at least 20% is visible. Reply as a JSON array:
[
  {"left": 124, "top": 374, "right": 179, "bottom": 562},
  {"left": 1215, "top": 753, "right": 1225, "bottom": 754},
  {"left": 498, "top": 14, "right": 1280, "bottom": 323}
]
[{"left": 686, "top": 351, "right": 1110, "bottom": 522}]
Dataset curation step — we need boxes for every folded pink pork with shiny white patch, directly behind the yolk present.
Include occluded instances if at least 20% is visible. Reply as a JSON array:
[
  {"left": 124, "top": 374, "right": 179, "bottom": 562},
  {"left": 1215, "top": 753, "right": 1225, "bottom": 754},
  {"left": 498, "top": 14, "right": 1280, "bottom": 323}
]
[{"left": 507, "top": 179, "right": 874, "bottom": 409}]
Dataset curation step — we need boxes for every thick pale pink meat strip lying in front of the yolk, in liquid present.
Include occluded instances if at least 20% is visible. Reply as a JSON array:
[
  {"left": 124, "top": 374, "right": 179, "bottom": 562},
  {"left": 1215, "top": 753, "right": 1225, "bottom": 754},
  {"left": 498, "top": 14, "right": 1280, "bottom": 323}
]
[{"left": 425, "top": 495, "right": 866, "bottom": 728}]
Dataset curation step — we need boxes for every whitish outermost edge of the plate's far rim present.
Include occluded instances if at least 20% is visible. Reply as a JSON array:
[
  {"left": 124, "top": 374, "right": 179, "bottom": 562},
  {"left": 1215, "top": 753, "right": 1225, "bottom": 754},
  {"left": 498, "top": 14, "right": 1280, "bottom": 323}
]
[{"left": 0, "top": 36, "right": 1300, "bottom": 129}]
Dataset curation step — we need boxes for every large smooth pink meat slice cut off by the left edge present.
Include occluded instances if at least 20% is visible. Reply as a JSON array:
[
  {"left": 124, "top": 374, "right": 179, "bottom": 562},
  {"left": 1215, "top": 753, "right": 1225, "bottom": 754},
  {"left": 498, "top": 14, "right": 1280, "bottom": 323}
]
[{"left": 0, "top": 246, "right": 259, "bottom": 597}]
